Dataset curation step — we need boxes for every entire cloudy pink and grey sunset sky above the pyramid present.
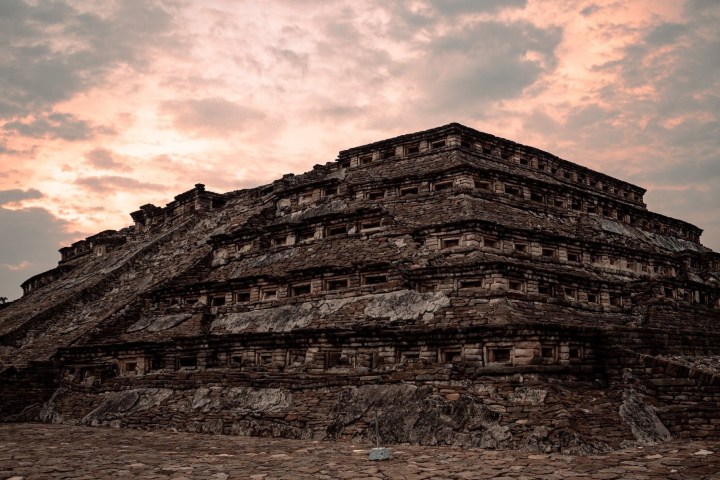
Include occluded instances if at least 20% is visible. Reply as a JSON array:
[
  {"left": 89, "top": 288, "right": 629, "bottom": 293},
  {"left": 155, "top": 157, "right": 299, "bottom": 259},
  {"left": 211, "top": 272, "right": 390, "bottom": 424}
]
[{"left": 0, "top": 0, "right": 720, "bottom": 299}]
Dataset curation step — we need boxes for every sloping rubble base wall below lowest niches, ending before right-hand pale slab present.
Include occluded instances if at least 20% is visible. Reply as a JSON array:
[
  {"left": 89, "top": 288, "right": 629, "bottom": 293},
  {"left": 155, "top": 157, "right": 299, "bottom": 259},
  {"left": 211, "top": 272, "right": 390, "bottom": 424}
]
[{"left": 35, "top": 369, "right": 633, "bottom": 453}]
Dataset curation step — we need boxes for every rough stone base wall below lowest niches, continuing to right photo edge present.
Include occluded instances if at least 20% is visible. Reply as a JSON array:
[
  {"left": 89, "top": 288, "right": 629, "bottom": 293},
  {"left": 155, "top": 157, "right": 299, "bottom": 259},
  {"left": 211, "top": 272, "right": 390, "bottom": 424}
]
[{"left": 35, "top": 352, "right": 720, "bottom": 453}]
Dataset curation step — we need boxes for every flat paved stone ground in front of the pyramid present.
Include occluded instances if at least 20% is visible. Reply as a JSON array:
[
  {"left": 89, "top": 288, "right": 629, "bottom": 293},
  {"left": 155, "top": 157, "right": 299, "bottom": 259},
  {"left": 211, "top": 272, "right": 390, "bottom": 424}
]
[{"left": 0, "top": 424, "right": 720, "bottom": 480}]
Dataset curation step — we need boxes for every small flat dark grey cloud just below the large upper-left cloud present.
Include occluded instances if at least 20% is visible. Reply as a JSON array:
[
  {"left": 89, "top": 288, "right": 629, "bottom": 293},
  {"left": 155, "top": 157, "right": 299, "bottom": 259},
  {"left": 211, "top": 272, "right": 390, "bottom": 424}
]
[{"left": 2, "top": 113, "right": 113, "bottom": 141}]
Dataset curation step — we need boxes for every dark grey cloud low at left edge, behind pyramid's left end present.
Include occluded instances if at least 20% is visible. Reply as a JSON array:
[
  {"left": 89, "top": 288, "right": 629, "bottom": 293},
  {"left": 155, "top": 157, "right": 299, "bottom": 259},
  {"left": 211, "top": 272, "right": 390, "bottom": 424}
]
[{"left": 0, "top": 207, "right": 74, "bottom": 299}]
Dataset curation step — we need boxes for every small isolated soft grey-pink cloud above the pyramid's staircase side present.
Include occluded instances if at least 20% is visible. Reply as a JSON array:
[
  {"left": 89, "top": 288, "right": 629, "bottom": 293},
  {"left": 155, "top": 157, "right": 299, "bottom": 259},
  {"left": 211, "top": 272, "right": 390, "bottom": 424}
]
[{"left": 162, "top": 98, "right": 265, "bottom": 135}]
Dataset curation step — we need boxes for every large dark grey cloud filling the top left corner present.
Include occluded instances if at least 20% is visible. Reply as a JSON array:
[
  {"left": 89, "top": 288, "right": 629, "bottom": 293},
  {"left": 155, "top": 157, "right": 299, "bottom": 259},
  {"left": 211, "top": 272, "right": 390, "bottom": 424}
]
[{"left": 0, "top": 0, "right": 179, "bottom": 119}]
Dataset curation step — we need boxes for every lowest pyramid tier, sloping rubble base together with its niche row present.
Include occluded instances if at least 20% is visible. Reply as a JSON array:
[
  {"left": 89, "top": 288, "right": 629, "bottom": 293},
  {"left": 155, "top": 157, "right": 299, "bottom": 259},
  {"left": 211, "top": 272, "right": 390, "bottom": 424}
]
[{"left": 18, "top": 325, "right": 720, "bottom": 453}]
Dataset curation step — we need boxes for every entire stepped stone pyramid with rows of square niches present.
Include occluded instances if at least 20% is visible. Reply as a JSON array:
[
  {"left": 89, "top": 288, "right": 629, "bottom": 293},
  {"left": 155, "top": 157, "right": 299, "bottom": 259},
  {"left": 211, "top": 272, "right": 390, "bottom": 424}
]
[{"left": 0, "top": 123, "right": 720, "bottom": 453}]
